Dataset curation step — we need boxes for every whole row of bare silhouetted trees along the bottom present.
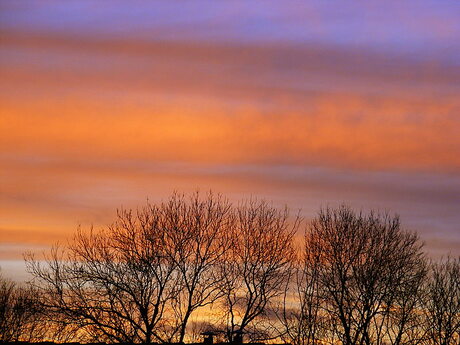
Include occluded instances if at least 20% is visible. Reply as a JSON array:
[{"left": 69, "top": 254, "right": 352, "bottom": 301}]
[{"left": 0, "top": 193, "right": 460, "bottom": 345}]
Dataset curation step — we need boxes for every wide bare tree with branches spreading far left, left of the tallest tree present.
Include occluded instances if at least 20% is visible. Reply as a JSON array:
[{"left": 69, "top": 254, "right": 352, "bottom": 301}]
[{"left": 27, "top": 206, "right": 178, "bottom": 343}]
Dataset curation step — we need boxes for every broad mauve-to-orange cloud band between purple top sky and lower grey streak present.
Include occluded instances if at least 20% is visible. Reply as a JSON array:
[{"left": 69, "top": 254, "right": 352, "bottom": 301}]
[{"left": 0, "top": 28, "right": 460, "bottom": 172}]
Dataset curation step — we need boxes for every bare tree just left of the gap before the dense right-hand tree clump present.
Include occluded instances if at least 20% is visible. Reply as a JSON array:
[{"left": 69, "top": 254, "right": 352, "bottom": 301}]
[{"left": 220, "top": 200, "right": 300, "bottom": 341}]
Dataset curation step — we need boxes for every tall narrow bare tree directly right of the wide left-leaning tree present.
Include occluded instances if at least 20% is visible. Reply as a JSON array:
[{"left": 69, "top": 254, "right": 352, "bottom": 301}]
[{"left": 158, "top": 193, "right": 234, "bottom": 342}]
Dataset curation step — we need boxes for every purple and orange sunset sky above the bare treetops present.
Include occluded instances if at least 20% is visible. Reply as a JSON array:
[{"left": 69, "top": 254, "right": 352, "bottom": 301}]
[{"left": 0, "top": 0, "right": 460, "bottom": 279}]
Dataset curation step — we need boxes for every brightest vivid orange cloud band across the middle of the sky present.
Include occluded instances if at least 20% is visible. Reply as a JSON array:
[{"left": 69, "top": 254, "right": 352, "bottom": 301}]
[{"left": 0, "top": 96, "right": 460, "bottom": 172}]
